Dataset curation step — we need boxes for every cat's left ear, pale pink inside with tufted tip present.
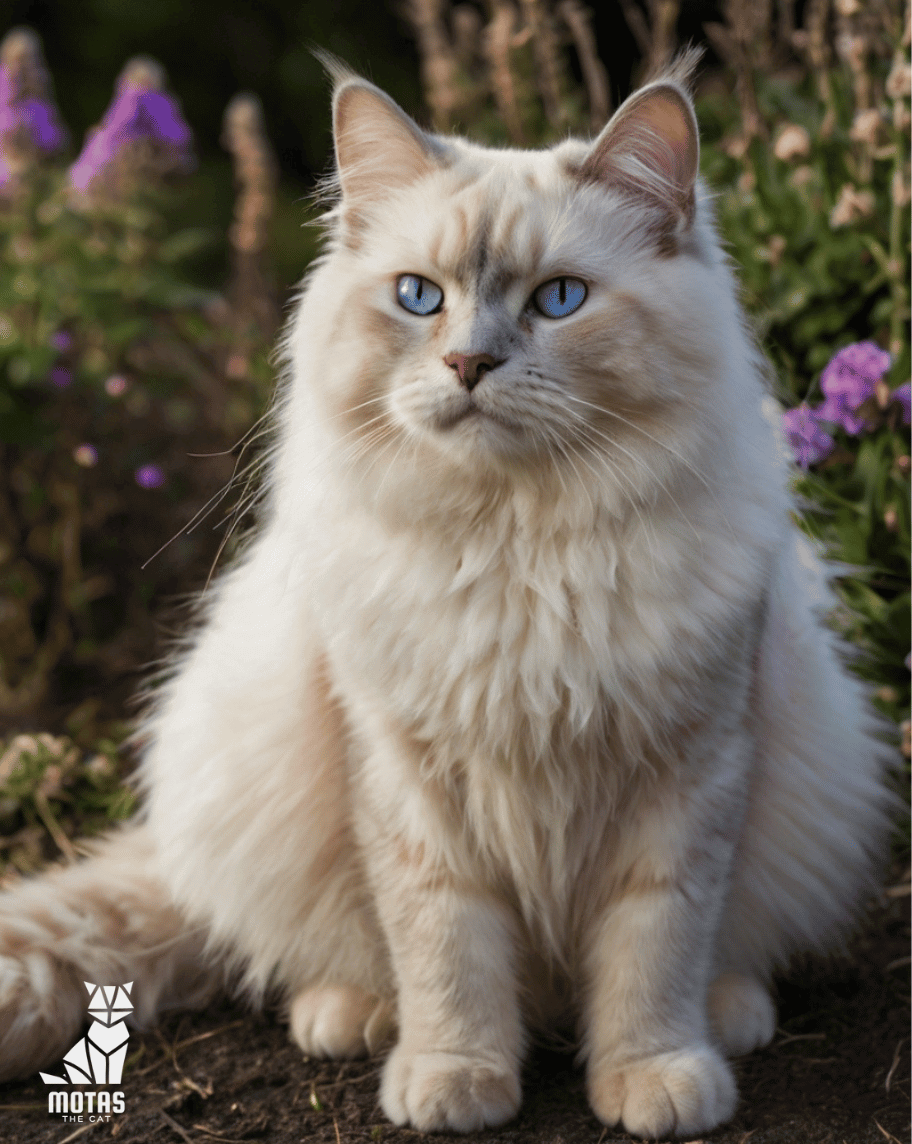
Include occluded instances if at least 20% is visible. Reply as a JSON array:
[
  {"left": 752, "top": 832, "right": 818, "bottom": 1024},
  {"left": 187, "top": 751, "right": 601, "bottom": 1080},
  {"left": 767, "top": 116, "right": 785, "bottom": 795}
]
[{"left": 333, "top": 76, "right": 441, "bottom": 204}]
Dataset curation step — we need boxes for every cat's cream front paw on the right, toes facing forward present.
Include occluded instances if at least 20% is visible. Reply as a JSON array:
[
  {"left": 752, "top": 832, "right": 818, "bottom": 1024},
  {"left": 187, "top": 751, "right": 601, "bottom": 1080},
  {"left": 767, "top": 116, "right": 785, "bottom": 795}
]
[{"left": 588, "top": 1044, "right": 738, "bottom": 1138}]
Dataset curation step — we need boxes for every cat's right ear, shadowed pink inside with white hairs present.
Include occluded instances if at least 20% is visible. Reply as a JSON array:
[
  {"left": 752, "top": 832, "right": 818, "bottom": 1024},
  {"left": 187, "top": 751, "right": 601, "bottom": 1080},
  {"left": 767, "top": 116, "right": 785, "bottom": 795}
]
[{"left": 580, "top": 80, "right": 700, "bottom": 221}]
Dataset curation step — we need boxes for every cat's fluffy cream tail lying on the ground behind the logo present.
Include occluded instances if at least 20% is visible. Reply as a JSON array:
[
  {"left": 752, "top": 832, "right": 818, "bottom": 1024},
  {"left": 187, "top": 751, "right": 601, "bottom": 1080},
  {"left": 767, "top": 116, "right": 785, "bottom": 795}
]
[{"left": 0, "top": 824, "right": 222, "bottom": 1081}]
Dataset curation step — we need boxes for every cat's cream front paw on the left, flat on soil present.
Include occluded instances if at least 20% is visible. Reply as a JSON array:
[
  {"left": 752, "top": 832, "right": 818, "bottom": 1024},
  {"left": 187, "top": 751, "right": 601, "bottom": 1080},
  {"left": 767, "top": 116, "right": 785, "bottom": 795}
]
[{"left": 380, "top": 1043, "right": 522, "bottom": 1133}]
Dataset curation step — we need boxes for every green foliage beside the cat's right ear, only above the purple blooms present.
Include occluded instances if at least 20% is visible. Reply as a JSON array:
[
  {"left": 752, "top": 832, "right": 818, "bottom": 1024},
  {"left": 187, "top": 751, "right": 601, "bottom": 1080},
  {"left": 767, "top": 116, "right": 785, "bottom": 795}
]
[{"left": 699, "top": 72, "right": 910, "bottom": 404}]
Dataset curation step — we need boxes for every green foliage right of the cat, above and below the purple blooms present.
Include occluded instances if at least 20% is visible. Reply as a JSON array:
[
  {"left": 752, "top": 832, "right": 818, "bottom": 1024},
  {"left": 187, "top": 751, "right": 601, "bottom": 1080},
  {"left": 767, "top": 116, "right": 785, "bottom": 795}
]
[{"left": 699, "top": 61, "right": 910, "bottom": 722}]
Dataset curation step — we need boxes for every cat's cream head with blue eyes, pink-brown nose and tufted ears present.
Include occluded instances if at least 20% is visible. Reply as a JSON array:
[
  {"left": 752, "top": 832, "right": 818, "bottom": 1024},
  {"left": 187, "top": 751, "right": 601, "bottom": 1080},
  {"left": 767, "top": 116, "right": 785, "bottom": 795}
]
[{"left": 291, "top": 55, "right": 738, "bottom": 512}]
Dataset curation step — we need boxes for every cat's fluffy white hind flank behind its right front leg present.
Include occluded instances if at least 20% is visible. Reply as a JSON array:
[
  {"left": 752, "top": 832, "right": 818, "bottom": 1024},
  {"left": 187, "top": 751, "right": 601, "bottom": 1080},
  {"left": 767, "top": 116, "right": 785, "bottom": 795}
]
[{"left": 720, "top": 535, "right": 896, "bottom": 977}]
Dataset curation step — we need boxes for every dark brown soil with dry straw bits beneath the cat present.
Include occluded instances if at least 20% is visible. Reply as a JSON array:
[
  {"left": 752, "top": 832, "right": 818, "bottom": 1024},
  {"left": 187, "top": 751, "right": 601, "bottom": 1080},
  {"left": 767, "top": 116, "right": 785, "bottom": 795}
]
[{"left": 0, "top": 879, "right": 910, "bottom": 1144}]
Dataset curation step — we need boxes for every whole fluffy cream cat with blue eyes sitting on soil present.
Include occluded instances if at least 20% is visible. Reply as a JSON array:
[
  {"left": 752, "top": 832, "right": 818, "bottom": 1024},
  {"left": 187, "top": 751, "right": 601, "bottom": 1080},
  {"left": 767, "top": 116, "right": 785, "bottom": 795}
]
[{"left": 0, "top": 56, "right": 888, "bottom": 1137}]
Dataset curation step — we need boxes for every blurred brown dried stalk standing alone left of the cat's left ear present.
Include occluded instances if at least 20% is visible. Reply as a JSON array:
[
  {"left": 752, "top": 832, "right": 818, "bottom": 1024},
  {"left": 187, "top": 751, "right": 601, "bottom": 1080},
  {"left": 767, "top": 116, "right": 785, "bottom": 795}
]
[{"left": 222, "top": 93, "right": 279, "bottom": 334}]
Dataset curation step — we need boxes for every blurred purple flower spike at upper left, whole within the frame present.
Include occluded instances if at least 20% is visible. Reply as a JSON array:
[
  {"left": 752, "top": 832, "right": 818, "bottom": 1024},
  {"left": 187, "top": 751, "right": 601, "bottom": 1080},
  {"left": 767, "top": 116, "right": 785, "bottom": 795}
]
[{"left": 70, "top": 57, "right": 193, "bottom": 191}]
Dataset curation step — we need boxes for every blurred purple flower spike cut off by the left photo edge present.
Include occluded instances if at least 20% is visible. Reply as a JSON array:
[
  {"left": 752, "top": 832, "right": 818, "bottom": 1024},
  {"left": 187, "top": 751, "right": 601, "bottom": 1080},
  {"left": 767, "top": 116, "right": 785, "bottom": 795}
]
[{"left": 0, "top": 27, "right": 68, "bottom": 188}]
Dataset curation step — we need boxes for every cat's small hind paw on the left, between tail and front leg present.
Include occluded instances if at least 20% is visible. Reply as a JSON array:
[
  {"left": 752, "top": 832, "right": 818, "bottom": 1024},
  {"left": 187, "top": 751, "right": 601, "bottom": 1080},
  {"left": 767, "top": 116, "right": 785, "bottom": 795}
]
[{"left": 288, "top": 985, "right": 396, "bottom": 1060}]
